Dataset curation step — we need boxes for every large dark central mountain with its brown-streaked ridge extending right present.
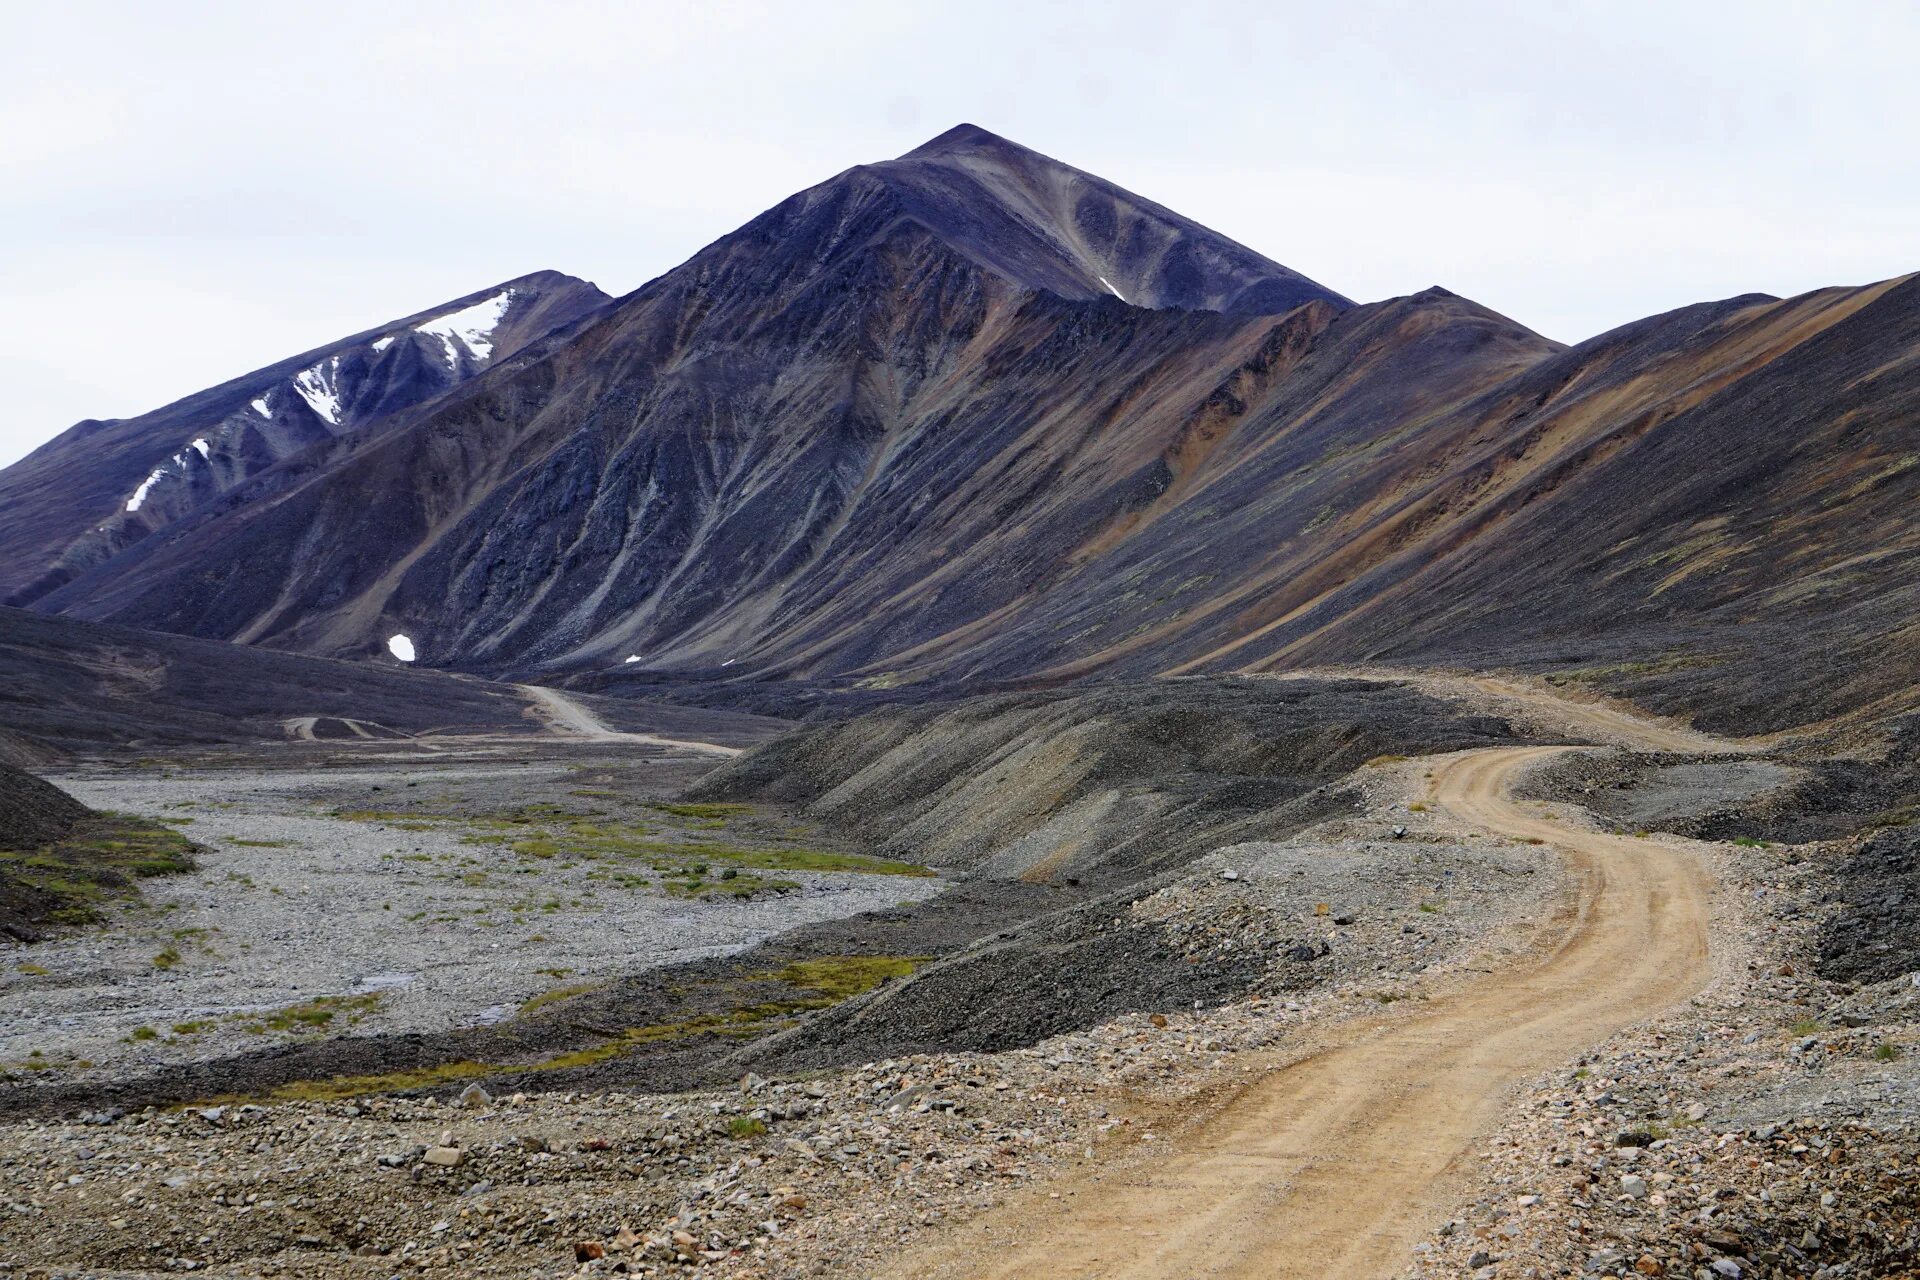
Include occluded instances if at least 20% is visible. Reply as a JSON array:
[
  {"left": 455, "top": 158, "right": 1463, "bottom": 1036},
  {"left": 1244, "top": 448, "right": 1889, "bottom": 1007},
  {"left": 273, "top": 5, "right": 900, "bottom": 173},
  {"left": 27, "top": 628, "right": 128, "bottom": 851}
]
[{"left": 7, "top": 127, "right": 1920, "bottom": 729}]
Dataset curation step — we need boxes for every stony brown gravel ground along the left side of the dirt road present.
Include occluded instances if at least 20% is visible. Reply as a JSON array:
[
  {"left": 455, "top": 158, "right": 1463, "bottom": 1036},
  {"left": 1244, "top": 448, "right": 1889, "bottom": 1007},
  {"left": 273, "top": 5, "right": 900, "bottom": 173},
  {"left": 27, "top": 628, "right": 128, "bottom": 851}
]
[{"left": 0, "top": 766, "right": 1557, "bottom": 1280}]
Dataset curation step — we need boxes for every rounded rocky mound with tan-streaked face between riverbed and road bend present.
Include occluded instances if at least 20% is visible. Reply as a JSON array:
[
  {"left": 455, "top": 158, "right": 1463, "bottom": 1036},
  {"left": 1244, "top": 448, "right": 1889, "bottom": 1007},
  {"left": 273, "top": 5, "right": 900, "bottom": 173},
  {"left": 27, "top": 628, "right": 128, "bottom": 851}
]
[{"left": 689, "top": 677, "right": 1519, "bottom": 885}]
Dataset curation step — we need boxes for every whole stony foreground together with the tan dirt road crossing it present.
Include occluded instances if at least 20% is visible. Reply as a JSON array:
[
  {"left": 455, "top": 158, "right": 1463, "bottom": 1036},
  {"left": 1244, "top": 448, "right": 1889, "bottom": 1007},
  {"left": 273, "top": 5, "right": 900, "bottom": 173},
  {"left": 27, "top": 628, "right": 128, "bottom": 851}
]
[{"left": 0, "top": 687, "right": 1920, "bottom": 1280}]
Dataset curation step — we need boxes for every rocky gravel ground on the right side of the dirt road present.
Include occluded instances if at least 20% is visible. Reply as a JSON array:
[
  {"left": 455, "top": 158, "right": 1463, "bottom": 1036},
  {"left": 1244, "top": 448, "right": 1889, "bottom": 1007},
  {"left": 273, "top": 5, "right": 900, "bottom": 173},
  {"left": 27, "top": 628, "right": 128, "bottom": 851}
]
[{"left": 1407, "top": 825, "right": 1920, "bottom": 1280}]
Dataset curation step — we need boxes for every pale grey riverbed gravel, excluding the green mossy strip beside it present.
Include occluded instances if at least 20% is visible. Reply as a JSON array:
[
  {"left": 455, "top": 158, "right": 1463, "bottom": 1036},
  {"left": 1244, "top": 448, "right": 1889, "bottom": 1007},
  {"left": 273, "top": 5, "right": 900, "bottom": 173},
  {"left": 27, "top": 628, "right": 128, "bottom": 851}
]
[{"left": 0, "top": 748, "right": 939, "bottom": 1080}]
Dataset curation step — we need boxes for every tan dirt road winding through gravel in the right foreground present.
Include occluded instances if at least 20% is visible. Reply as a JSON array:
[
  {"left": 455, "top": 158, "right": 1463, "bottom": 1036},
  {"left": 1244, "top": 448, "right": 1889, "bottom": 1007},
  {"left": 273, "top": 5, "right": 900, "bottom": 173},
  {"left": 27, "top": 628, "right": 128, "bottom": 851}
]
[{"left": 885, "top": 694, "right": 1709, "bottom": 1280}]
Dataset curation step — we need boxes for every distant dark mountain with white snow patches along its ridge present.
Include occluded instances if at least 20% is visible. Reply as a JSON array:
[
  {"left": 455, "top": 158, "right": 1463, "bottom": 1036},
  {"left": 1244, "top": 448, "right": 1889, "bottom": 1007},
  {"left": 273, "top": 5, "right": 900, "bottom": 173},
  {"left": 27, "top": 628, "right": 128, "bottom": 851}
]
[{"left": 0, "top": 271, "right": 607, "bottom": 604}]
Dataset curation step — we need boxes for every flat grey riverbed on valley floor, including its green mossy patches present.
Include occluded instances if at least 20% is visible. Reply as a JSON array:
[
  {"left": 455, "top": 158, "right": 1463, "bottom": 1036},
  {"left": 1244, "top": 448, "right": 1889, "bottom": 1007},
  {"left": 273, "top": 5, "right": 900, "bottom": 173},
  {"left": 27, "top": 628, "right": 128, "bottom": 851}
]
[{"left": 0, "top": 735, "right": 939, "bottom": 1090}]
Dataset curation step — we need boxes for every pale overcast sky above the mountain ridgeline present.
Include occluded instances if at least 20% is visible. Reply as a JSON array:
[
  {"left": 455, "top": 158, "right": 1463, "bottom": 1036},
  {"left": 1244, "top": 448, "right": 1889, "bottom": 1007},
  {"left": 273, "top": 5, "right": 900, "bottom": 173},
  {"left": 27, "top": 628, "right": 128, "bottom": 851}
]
[{"left": 0, "top": 0, "right": 1920, "bottom": 464}]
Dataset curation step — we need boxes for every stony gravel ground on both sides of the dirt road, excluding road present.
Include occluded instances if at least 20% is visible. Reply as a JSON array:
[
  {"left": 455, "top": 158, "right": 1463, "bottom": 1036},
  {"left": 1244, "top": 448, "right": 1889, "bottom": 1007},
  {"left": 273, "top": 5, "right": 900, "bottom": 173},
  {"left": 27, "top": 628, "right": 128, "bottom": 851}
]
[{"left": 0, "top": 729, "right": 1920, "bottom": 1280}]
